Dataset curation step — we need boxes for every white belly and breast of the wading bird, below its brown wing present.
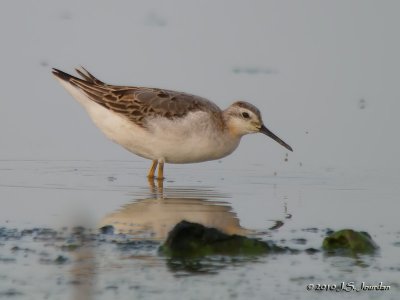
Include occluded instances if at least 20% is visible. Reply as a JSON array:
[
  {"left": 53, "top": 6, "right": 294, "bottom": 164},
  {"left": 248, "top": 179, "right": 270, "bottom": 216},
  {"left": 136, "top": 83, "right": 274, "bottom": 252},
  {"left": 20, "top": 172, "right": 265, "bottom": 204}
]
[{"left": 61, "top": 81, "right": 240, "bottom": 163}]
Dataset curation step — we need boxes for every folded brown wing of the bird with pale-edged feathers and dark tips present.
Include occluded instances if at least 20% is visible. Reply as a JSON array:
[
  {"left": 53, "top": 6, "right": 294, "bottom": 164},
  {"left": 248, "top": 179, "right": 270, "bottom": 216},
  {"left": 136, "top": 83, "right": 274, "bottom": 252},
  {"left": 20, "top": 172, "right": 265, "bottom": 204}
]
[{"left": 53, "top": 68, "right": 221, "bottom": 127}]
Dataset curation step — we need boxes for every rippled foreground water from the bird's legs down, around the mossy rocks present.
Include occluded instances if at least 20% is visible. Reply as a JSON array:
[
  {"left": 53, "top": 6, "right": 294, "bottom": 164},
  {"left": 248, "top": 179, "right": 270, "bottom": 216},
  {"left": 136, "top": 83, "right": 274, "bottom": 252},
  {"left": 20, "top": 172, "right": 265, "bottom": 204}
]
[{"left": 0, "top": 161, "right": 400, "bottom": 299}]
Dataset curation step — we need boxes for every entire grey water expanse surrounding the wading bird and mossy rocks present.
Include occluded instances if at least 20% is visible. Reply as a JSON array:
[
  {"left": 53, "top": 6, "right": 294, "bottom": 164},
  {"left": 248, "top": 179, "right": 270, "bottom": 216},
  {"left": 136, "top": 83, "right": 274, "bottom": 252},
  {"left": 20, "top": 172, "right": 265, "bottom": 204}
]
[{"left": 0, "top": 0, "right": 400, "bottom": 300}]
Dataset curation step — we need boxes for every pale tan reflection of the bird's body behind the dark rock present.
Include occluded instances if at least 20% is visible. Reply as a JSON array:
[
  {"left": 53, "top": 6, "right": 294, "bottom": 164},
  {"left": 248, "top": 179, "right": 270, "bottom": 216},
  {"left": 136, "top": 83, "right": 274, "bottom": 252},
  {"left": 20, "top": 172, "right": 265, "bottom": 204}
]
[{"left": 100, "top": 186, "right": 251, "bottom": 241}]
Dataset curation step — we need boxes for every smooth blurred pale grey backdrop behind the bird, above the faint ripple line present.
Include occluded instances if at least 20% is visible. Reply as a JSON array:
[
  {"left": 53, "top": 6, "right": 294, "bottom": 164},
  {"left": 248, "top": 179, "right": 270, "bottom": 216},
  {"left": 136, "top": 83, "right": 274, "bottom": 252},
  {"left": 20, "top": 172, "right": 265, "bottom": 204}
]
[{"left": 0, "top": 0, "right": 400, "bottom": 172}]
